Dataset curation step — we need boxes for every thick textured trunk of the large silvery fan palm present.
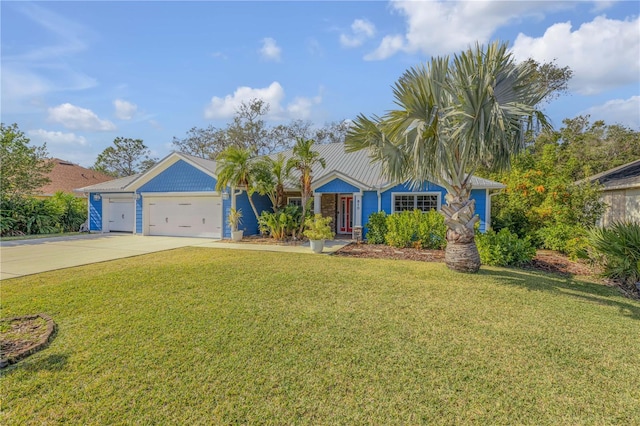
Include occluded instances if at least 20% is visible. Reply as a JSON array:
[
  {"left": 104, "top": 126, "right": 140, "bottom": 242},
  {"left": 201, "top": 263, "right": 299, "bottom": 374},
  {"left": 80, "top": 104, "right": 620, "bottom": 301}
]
[{"left": 442, "top": 187, "right": 480, "bottom": 272}]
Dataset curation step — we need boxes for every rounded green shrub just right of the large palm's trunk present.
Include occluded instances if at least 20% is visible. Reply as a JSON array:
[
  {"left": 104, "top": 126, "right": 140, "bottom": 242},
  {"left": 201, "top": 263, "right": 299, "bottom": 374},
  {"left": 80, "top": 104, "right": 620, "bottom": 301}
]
[{"left": 476, "top": 228, "right": 536, "bottom": 266}]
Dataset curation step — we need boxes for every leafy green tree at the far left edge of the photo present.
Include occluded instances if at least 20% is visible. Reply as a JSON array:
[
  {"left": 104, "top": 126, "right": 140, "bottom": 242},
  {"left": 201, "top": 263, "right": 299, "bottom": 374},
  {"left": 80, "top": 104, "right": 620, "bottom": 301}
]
[{"left": 0, "top": 123, "right": 54, "bottom": 198}]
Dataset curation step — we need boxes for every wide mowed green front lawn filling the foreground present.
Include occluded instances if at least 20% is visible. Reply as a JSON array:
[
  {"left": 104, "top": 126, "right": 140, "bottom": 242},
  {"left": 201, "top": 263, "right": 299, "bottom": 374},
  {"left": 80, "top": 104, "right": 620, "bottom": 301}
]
[{"left": 0, "top": 248, "right": 640, "bottom": 425}]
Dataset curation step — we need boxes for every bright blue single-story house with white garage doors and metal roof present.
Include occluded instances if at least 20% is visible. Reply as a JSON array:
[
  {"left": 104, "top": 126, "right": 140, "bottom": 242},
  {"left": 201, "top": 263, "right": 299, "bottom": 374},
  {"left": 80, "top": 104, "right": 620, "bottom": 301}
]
[{"left": 77, "top": 143, "right": 504, "bottom": 238}]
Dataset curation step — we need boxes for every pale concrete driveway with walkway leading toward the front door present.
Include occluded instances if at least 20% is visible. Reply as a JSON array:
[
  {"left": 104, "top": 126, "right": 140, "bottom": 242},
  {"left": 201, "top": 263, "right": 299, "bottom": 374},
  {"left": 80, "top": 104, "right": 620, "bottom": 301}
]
[{"left": 0, "top": 234, "right": 349, "bottom": 280}]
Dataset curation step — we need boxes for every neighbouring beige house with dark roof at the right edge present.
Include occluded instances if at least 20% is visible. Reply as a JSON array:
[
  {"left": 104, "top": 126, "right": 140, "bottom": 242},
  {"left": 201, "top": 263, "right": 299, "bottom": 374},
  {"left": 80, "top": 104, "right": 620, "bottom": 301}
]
[{"left": 587, "top": 159, "right": 640, "bottom": 226}]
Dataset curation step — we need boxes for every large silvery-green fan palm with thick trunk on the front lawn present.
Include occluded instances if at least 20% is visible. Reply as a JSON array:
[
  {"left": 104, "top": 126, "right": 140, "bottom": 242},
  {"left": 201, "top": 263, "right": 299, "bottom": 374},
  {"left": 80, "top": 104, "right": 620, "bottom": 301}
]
[{"left": 346, "top": 42, "right": 549, "bottom": 272}]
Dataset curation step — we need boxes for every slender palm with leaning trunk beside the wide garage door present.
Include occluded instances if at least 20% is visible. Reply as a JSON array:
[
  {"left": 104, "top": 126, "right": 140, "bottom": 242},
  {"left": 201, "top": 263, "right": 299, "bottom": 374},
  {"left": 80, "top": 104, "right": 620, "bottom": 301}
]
[{"left": 216, "top": 145, "right": 258, "bottom": 219}]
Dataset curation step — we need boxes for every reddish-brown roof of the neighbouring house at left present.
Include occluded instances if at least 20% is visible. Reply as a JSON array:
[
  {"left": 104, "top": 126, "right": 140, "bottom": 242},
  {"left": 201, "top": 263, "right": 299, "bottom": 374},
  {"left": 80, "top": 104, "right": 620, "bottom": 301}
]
[{"left": 37, "top": 158, "right": 114, "bottom": 197}]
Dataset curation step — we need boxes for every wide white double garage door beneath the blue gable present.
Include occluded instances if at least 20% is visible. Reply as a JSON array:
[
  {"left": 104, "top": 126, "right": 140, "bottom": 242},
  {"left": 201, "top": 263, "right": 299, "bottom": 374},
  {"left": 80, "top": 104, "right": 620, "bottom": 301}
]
[{"left": 147, "top": 197, "right": 222, "bottom": 238}]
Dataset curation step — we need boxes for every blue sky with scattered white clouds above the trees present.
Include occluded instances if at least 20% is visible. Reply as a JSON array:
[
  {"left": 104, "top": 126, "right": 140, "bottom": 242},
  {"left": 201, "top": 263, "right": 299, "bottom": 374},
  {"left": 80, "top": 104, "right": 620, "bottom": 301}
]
[{"left": 0, "top": 1, "right": 640, "bottom": 167}]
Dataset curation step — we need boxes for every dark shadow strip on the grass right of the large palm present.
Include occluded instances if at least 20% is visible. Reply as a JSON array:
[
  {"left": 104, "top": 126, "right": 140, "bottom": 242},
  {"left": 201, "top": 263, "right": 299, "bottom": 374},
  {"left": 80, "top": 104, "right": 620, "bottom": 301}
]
[{"left": 479, "top": 268, "right": 640, "bottom": 320}]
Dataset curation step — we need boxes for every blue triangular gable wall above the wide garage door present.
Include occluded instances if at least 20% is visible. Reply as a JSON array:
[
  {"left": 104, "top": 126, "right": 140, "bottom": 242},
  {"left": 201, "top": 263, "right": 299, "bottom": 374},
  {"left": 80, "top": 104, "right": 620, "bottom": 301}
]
[{"left": 138, "top": 160, "right": 217, "bottom": 192}]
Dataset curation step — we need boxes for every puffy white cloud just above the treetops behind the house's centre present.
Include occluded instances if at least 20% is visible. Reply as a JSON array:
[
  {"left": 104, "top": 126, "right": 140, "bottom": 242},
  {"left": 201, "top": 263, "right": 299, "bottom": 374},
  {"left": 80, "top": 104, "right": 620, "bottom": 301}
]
[{"left": 204, "top": 81, "right": 322, "bottom": 121}]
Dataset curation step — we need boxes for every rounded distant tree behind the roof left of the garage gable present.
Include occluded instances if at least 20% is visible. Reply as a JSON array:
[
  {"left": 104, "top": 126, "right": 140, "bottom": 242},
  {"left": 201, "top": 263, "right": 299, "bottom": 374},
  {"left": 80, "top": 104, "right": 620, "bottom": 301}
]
[{"left": 93, "top": 137, "right": 158, "bottom": 177}]
